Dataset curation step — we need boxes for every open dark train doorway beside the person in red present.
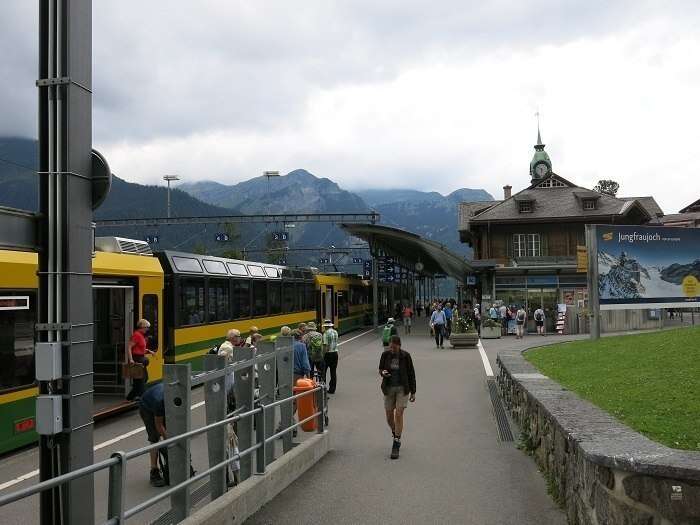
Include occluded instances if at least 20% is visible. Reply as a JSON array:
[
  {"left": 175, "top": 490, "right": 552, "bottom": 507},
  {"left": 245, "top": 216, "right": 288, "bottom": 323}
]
[{"left": 92, "top": 285, "right": 134, "bottom": 413}]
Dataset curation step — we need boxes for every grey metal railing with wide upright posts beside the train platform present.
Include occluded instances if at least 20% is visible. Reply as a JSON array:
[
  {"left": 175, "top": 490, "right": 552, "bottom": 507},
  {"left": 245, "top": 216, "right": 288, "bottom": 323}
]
[{"left": 0, "top": 337, "right": 327, "bottom": 525}]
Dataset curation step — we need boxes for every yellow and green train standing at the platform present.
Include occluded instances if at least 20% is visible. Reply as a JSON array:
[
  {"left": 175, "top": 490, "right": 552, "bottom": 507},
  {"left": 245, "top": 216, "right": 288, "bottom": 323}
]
[{"left": 0, "top": 237, "right": 372, "bottom": 453}]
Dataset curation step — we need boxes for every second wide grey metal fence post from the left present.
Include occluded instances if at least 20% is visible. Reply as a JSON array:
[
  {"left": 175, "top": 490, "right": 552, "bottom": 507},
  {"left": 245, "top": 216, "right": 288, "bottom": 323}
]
[{"left": 204, "top": 354, "right": 227, "bottom": 500}]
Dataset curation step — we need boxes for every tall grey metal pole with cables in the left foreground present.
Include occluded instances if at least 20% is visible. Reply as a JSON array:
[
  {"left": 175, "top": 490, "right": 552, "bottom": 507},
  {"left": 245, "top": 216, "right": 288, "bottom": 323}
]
[{"left": 36, "top": 0, "right": 94, "bottom": 525}]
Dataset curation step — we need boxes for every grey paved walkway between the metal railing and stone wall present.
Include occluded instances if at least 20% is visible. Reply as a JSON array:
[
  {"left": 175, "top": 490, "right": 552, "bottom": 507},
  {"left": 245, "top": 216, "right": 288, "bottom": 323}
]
[{"left": 248, "top": 329, "right": 566, "bottom": 525}]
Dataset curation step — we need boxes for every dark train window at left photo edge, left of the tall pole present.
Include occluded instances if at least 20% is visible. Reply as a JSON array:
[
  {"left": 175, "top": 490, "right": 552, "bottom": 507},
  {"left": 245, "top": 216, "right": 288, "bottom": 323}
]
[{"left": 0, "top": 294, "right": 35, "bottom": 391}]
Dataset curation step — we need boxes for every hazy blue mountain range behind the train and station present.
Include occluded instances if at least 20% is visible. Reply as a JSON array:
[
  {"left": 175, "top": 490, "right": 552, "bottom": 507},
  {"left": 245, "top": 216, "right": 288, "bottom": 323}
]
[{"left": 0, "top": 138, "right": 493, "bottom": 271}]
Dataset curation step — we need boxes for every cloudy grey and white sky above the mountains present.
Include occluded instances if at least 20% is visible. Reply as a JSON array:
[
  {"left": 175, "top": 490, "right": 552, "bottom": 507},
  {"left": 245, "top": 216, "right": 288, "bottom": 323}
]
[{"left": 0, "top": 0, "right": 700, "bottom": 212}]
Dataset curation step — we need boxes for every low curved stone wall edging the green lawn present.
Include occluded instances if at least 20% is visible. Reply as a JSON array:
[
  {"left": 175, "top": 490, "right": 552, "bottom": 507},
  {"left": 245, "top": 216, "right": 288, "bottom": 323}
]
[{"left": 498, "top": 351, "right": 700, "bottom": 525}]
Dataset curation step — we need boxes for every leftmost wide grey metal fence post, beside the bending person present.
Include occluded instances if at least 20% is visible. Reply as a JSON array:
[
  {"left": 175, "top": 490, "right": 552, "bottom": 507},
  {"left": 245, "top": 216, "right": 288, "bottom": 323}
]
[{"left": 163, "top": 363, "right": 192, "bottom": 523}]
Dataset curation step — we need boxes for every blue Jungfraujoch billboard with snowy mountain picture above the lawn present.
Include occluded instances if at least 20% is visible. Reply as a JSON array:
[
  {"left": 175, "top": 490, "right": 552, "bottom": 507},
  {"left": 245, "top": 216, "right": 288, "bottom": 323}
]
[{"left": 595, "top": 225, "right": 700, "bottom": 310}]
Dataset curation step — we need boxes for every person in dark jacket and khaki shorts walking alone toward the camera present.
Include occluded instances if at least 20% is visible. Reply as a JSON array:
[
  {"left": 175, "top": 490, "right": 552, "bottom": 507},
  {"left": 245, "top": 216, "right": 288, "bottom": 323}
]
[{"left": 379, "top": 335, "right": 416, "bottom": 459}]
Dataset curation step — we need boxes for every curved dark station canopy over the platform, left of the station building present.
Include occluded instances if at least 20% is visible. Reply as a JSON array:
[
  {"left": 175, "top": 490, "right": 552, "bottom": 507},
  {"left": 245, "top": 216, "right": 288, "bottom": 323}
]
[{"left": 340, "top": 224, "right": 473, "bottom": 283}]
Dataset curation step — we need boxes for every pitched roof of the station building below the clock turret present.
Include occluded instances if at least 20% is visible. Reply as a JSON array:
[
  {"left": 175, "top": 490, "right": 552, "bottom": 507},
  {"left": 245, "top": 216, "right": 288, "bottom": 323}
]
[{"left": 470, "top": 173, "right": 658, "bottom": 223}]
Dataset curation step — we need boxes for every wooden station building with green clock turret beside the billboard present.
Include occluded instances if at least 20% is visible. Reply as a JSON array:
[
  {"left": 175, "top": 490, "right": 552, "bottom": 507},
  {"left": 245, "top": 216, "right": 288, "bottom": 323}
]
[{"left": 458, "top": 130, "right": 663, "bottom": 333}]
